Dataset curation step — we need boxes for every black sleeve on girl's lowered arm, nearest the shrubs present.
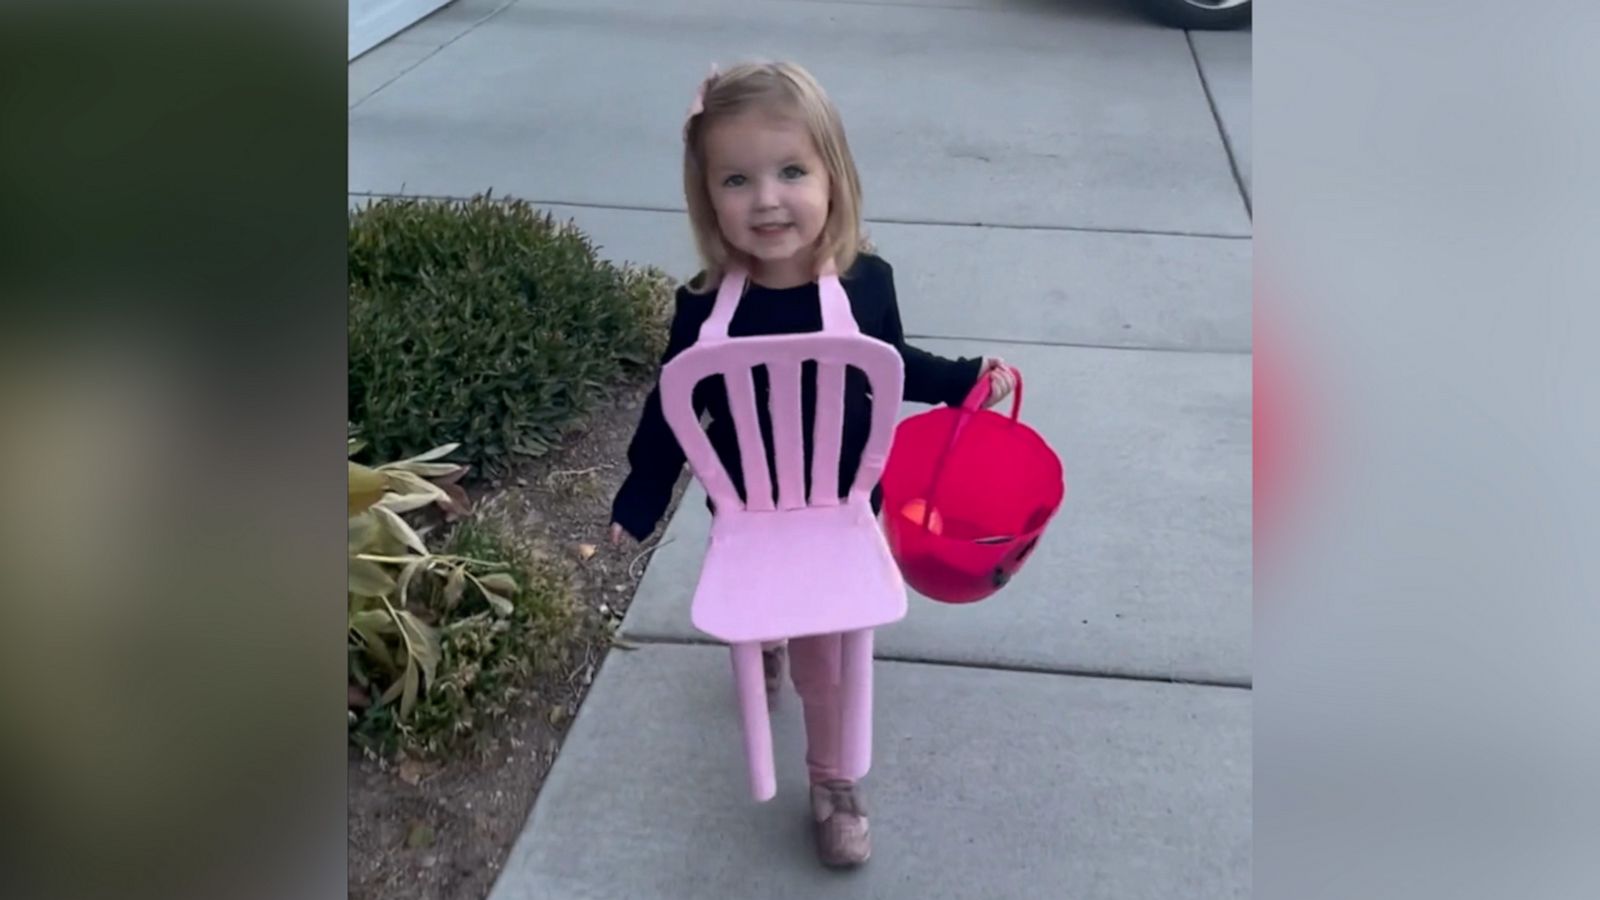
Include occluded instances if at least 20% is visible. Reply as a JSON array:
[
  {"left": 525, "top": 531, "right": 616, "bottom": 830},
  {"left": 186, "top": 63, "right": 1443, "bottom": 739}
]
[{"left": 611, "top": 287, "right": 712, "bottom": 541}]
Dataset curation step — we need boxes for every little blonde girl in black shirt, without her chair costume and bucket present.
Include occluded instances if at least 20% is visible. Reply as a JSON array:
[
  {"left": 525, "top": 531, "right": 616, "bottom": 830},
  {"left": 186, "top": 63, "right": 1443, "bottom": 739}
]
[{"left": 611, "top": 62, "right": 1013, "bottom": 866}]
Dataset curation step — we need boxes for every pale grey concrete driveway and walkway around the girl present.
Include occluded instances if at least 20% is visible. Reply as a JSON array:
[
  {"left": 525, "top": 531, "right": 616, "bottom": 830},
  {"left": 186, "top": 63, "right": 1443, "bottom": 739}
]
[{"left": 349, "top": 0, "right": 1251, "bottom": 900}]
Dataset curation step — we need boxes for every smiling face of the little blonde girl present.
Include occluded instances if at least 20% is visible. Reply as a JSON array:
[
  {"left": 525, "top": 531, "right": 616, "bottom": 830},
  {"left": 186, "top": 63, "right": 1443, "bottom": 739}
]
[{"left": 706, "top": 112, "right": 830, "bottom": 287}]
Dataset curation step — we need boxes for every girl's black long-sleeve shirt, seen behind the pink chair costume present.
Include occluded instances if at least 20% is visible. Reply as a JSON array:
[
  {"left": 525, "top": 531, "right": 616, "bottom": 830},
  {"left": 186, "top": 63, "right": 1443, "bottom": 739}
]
[{"left": 611, "top": 253, "right": 982, "bottom": 540}]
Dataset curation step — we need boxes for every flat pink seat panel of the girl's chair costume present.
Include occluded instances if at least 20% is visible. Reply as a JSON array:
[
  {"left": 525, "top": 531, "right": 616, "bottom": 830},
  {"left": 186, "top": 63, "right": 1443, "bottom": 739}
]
[{"left": 690, "top": 501, "right": 906, "bottom": 644}]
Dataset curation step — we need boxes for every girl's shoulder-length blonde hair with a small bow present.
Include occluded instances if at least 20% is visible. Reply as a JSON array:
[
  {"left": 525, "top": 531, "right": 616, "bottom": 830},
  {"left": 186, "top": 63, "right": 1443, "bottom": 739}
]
[{"left": 683, "top": 62, "right": 870, "bottom": 293}]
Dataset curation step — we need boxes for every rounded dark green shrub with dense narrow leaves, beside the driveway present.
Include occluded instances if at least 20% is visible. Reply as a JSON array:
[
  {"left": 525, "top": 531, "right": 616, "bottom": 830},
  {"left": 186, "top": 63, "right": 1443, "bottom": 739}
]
[{"left": 349, "top": 197, "right": 672, "bottom": 472}]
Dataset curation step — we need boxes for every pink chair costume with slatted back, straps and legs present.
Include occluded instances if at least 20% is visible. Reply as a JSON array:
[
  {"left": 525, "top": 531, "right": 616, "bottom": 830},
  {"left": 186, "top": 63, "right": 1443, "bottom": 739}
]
[{"left": 661, "top": 261, "right": 906, "bottom": 801}]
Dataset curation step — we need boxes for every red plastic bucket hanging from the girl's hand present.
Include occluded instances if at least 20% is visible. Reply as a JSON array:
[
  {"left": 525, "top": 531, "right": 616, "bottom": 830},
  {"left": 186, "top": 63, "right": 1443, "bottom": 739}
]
[{"left": 882, "top": 370, "right": 1067, "bottom": 604}]
